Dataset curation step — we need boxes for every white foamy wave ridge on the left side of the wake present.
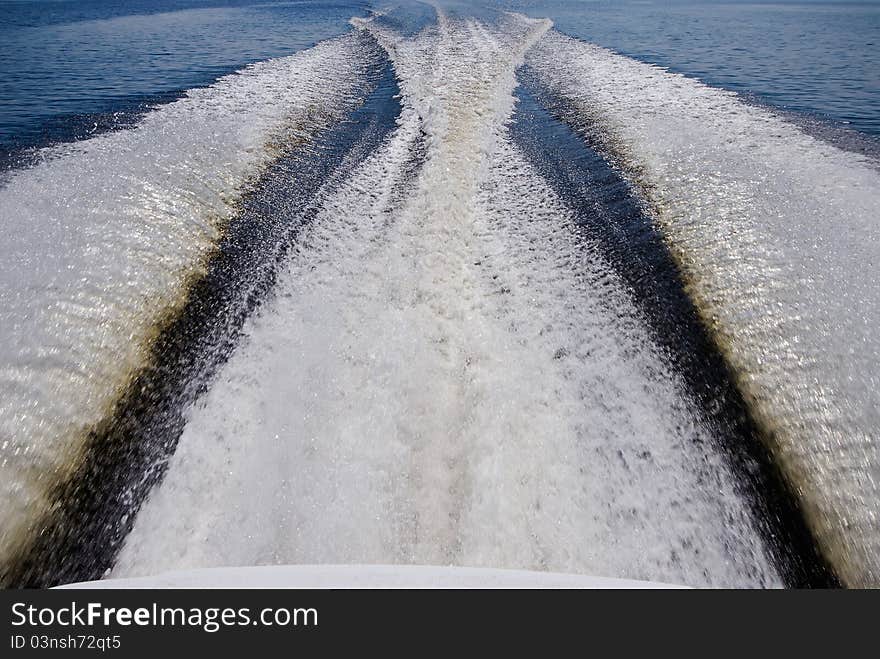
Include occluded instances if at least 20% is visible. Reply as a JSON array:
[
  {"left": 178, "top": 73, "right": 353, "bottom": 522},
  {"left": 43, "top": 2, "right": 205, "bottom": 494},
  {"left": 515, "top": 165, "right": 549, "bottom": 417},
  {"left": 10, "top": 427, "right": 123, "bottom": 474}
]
[{"left": 0, "top": 34, "right": 375, "bottom": 560}]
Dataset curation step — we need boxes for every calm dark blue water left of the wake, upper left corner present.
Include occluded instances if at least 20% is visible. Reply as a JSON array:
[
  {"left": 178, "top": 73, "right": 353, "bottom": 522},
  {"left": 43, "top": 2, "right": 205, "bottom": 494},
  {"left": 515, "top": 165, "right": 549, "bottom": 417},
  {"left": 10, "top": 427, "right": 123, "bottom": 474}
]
[{"left": 0, "top": 0, "right": 366, "bottom": 153}]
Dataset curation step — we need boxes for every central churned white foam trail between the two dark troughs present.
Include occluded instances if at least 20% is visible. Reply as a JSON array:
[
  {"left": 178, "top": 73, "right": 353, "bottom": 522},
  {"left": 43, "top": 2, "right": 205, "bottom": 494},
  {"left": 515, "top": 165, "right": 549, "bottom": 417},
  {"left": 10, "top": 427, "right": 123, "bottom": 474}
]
[{"left": 113, "top": 12, "right": 779, "bottom": 586}]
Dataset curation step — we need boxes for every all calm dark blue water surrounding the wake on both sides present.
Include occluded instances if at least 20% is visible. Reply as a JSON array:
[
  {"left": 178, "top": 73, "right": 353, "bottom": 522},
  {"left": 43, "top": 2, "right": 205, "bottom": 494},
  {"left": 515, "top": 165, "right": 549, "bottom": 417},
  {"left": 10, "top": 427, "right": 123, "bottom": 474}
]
[{"left": 0, "top": 0, "right": 880, "bottom": 156}]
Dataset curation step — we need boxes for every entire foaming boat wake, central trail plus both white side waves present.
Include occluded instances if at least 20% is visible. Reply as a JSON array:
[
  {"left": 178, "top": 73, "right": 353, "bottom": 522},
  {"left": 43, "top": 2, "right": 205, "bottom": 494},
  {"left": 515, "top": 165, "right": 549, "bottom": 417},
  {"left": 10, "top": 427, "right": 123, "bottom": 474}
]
[{"left": 0, "top": 9, "right": 880, "bottom": 586}]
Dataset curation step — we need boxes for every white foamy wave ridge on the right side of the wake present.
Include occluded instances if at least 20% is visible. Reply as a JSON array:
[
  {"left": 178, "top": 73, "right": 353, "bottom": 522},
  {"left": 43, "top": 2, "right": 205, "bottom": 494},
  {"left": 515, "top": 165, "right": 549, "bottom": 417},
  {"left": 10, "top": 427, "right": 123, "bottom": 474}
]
[{"left": 528, "top": 32, "right": 880, "bottom": 586}]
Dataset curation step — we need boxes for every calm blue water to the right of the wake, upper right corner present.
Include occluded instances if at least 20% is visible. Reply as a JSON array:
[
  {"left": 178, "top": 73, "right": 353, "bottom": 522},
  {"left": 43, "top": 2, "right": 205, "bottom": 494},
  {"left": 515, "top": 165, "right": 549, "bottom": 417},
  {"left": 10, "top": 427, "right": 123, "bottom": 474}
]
[{"left": 499, "top": 0, "right": 880, "bottom": 135}]
